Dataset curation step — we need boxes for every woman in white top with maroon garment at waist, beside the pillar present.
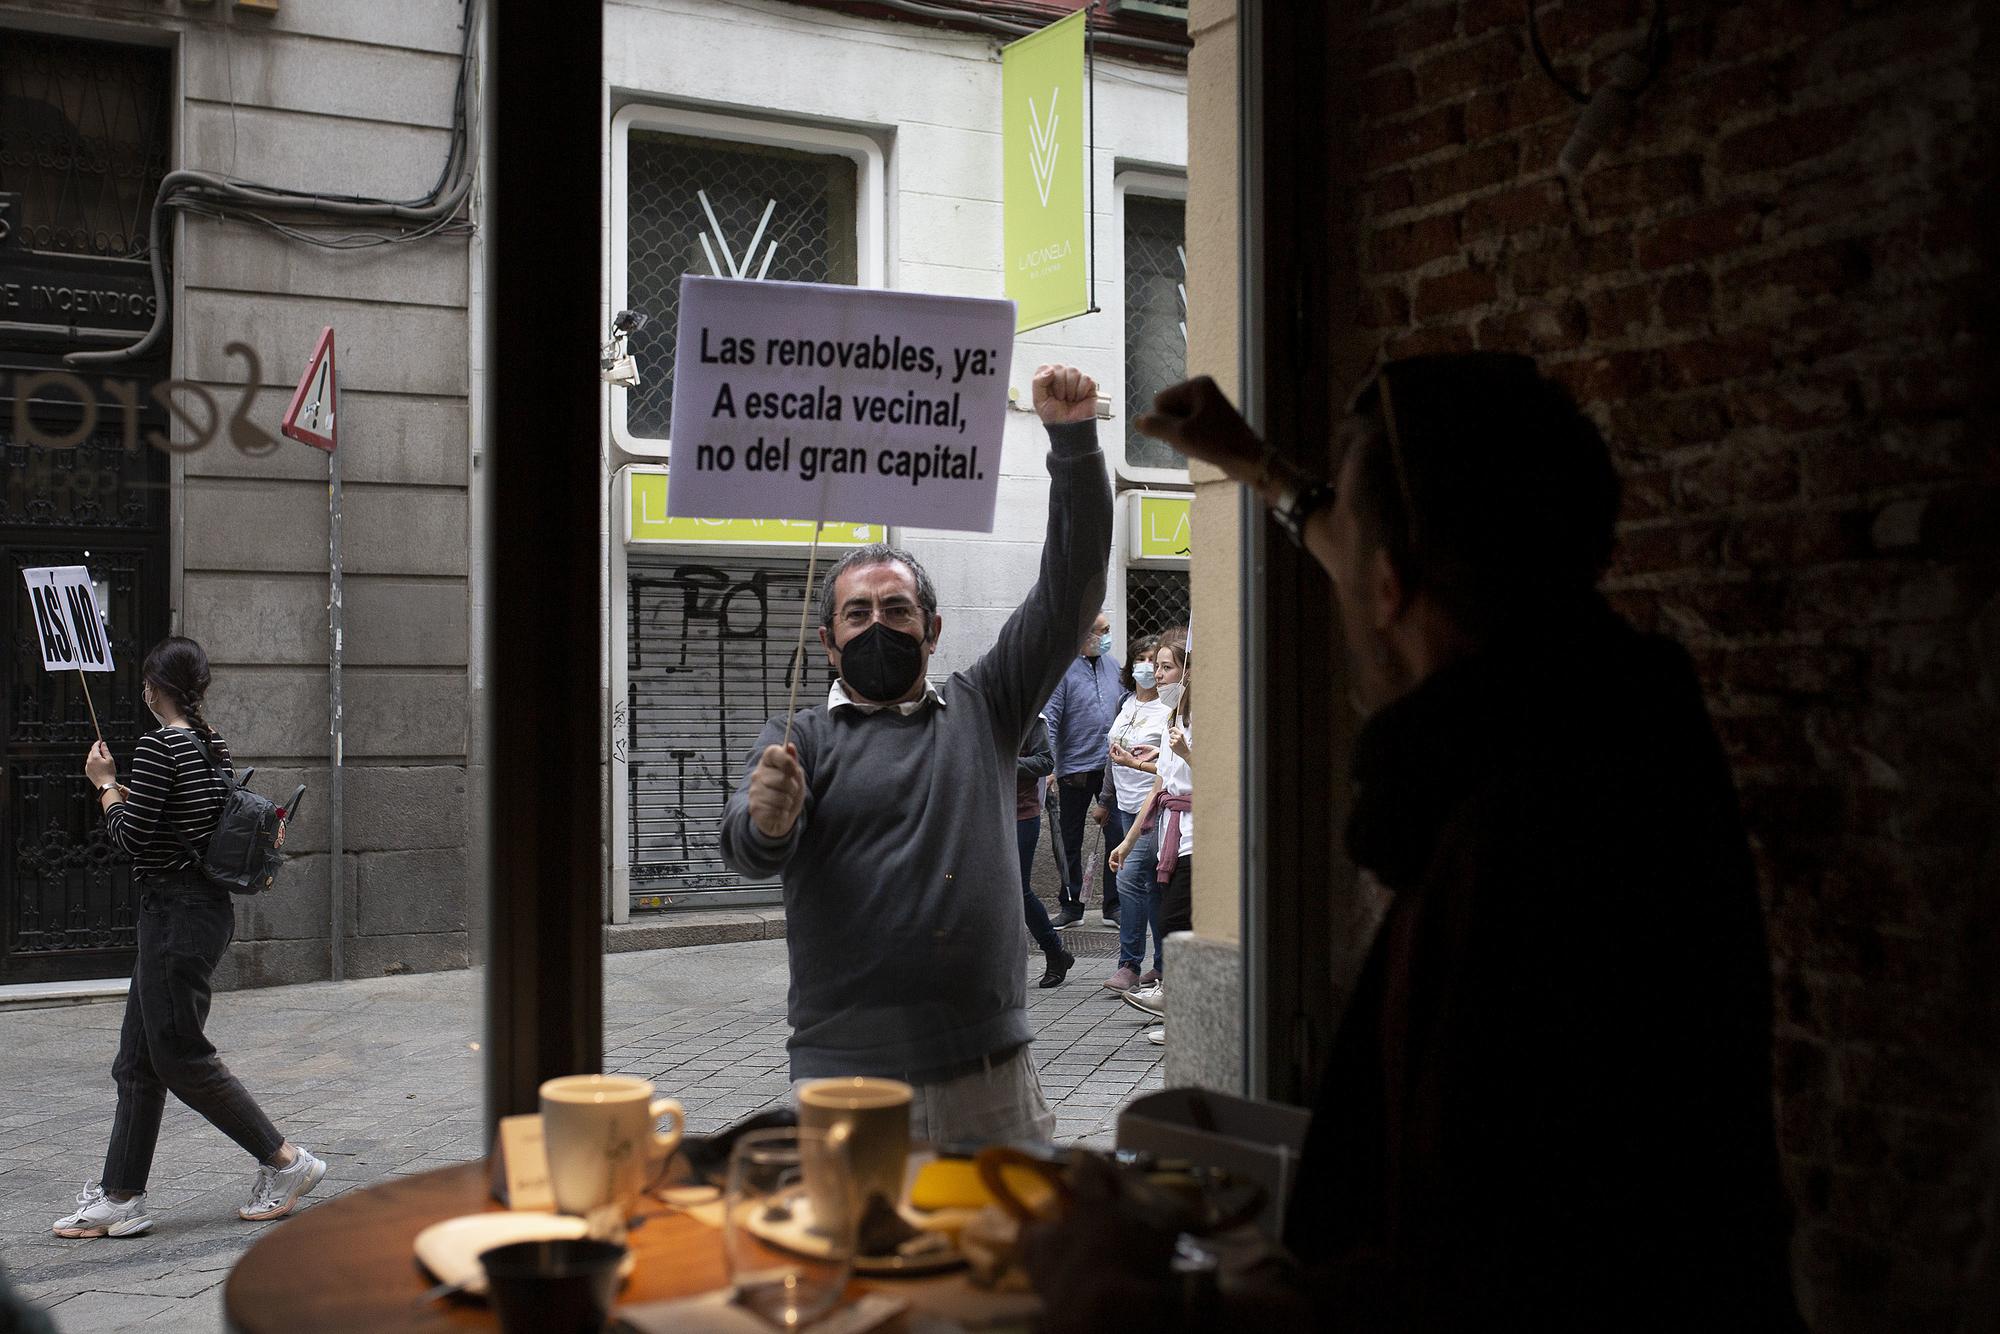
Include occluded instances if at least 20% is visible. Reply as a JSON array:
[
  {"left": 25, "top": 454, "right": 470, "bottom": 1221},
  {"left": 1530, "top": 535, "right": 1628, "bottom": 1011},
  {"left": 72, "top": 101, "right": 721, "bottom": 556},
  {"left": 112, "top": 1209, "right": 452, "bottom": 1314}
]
[{"left": 1112, "top": 642, "right": 1194, "bottom": 1044}]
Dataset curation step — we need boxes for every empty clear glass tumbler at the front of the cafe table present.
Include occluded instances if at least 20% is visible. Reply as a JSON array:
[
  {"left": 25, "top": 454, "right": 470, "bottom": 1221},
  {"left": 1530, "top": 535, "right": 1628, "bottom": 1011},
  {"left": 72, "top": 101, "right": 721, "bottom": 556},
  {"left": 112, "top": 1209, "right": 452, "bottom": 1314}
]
[{"left": 722, "top": 1126, "right": 854, "bottom": 1330}]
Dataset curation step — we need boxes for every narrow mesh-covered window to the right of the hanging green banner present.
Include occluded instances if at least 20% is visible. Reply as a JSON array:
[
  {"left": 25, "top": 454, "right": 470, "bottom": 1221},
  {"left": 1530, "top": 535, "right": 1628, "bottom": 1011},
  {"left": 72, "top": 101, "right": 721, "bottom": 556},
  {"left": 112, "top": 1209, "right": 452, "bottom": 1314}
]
[{"left": 1126, "top": 194, "right": 1188, "bottom": 468}]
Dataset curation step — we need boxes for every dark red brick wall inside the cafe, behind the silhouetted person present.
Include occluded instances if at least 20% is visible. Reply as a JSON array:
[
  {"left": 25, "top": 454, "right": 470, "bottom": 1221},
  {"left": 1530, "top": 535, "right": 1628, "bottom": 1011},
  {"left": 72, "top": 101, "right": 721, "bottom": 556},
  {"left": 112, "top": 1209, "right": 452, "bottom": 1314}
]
[{"left": 1350, "top": 0, "right": 2000, "bottom": 1332}]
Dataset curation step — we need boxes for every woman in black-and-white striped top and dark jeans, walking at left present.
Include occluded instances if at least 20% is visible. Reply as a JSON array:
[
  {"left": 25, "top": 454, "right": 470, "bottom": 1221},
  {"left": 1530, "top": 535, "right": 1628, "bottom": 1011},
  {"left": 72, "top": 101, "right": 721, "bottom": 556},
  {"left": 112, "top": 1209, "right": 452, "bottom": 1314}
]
[{"left": 54, "top": 636, "right": 326, "bottom": 1238}]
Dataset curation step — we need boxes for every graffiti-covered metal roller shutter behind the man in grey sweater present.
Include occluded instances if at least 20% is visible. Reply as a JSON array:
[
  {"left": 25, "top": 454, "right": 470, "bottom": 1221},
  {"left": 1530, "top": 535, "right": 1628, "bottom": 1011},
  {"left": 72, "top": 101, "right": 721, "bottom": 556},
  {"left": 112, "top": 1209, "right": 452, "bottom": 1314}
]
[{"left": 626, "top": 550, "right": 828, "bottom": 912}]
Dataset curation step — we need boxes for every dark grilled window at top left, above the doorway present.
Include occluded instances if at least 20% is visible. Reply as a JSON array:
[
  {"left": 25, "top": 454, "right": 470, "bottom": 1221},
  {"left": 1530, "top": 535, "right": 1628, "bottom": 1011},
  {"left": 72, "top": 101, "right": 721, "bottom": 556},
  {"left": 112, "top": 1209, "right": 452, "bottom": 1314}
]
[{"left": 0, "top": 32, "right": 170, "bottom": 260}]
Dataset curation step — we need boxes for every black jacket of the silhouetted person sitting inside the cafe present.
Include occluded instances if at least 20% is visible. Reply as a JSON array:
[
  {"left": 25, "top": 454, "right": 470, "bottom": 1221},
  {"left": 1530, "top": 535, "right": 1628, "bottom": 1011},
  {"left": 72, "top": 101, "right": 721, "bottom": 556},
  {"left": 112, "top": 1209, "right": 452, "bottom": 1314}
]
[{"left": 1286, "top": 600, "right": 1796, "bottom": 1330}]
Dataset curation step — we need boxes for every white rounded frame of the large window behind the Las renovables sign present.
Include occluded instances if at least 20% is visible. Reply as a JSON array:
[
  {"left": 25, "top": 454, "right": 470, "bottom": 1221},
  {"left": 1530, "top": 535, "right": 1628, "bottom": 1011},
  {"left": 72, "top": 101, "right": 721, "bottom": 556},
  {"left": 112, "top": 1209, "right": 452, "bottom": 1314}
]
[{"left": 604, "top": 102, "right": 888, "bottom": 462}]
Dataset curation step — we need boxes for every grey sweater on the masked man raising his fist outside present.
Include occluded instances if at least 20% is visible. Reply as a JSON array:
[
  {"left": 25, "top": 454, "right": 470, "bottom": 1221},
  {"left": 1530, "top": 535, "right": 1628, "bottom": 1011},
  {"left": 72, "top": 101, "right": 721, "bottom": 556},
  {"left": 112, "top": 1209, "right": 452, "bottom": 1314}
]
[{"left": 722, "top": 422, "right": 1112, "bottom": 1078}]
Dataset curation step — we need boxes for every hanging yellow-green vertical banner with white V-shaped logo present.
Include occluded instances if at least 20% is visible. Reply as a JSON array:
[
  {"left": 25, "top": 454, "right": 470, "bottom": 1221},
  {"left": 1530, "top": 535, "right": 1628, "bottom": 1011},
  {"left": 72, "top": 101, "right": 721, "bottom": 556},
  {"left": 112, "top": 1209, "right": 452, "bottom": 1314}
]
[{"left": 1000, "top": 10, "right": 1090, "bottom": 332}]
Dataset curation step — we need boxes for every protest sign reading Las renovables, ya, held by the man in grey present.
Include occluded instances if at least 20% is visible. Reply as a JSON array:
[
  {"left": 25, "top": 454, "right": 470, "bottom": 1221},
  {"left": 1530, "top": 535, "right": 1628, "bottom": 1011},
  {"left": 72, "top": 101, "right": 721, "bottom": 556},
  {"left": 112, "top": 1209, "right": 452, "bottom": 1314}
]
[{"left": 666, "top": 274, "right": 1014, "bottom": 532}]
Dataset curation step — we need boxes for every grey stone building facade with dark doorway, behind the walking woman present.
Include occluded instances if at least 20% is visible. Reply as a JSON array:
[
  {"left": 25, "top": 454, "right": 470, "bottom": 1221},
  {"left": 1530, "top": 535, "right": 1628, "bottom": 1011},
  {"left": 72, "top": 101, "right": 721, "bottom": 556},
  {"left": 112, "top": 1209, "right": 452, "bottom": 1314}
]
[{"left": 0, "top": 0, "right": 478, "bottom": 986}]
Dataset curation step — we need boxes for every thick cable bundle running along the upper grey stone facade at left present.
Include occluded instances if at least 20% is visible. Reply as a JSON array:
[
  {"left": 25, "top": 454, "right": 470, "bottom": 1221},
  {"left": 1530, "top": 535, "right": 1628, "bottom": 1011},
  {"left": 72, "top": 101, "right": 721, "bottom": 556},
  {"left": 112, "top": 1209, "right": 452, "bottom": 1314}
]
[{"left": 62, "top": 0, "right": 478, "bottom": 366}]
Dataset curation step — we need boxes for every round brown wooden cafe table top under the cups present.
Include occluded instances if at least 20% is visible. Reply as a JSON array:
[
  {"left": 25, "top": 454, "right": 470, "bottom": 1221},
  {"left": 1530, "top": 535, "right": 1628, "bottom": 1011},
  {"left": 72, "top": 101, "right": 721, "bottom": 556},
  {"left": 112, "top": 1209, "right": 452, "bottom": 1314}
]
[{"left": 222, "top": 1158, "right": 1018, "bottom": 1334}]
